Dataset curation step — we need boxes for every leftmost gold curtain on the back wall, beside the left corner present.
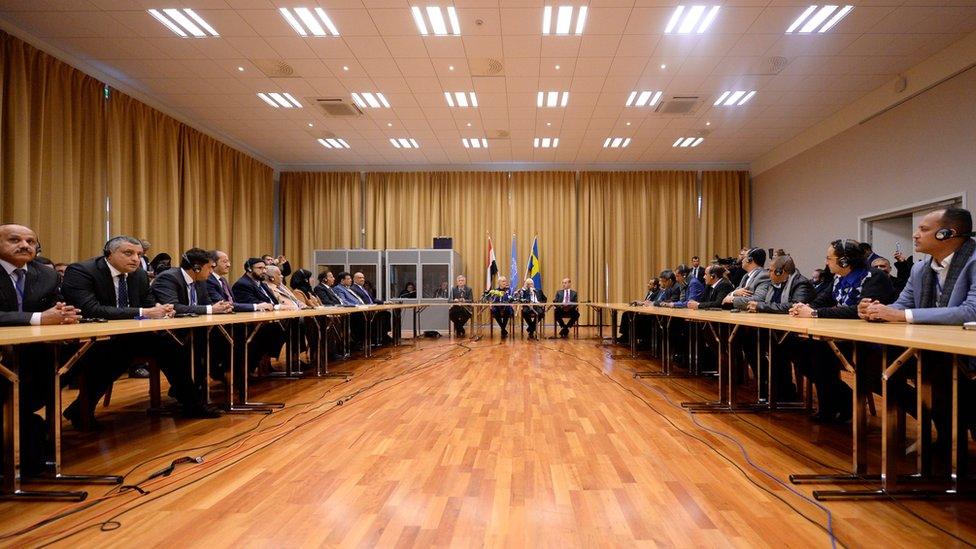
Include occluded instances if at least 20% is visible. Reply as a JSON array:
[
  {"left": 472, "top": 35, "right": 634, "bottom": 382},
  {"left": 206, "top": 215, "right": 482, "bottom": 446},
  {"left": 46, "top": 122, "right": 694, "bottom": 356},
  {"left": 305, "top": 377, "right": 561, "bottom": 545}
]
[{"left": 279, "top": 172, "right": 362, "bottom": 268}]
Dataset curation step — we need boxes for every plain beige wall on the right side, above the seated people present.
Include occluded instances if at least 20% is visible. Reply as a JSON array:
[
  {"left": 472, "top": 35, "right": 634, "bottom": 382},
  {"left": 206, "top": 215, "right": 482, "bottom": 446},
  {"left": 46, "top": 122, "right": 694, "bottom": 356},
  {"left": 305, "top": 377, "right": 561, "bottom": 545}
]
[{"left": 752, "top": 68, "right": 976, "bottom": 273}]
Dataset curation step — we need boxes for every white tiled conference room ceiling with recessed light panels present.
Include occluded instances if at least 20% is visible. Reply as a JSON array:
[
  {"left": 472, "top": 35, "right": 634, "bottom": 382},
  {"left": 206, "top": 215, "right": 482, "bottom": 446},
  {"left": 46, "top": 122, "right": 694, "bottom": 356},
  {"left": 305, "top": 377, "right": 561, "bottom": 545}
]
[{"left": 0, "top": 0, "right": 976, "bottom": 168}]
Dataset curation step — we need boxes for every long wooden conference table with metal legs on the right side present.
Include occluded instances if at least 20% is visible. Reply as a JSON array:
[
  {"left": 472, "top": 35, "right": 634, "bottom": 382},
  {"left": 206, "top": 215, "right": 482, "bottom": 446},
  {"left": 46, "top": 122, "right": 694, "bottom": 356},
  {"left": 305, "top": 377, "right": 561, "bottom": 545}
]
[{"left": 590, "top": 303, "right": 976, "bottom": 500}]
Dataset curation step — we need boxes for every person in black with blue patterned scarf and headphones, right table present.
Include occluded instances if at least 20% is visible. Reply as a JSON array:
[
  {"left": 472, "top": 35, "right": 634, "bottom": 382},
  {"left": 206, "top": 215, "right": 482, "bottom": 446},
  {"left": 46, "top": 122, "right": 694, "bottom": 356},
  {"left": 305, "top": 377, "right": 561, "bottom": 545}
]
[{"left": 787, "top": 239, "right": 892, "bottom": 423}]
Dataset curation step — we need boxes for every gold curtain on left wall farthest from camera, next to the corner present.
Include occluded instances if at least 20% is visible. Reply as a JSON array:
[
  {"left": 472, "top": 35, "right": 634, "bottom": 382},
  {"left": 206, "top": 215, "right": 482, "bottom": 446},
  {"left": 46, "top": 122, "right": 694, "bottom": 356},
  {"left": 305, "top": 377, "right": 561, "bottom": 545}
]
[{"left": 179, "top": 127, "right": 274, "bottom": 278}]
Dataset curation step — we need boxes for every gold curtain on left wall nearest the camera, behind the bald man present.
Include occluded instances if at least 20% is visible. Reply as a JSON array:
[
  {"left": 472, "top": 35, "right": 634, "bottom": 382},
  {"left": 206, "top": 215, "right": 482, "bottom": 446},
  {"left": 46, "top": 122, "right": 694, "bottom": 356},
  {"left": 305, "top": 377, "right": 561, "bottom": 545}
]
[{"left": 0, "top": 31, "right": 105, "bottom": 262}]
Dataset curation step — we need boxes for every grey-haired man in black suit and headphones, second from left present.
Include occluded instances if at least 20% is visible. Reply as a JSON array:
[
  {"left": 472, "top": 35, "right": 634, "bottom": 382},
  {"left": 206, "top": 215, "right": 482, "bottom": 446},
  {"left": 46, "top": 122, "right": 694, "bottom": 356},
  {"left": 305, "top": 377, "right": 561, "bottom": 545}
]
[{"left": 61, "top": 236, "right": 220, "bottom": 420}]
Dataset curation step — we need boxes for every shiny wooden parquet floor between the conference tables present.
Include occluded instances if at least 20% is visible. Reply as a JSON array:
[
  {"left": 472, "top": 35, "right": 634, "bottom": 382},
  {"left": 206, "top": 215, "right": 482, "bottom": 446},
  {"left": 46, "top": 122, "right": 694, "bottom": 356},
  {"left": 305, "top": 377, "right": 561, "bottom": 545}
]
[{"left": 0, "top": 332, "right": 976, "bottom": 548}]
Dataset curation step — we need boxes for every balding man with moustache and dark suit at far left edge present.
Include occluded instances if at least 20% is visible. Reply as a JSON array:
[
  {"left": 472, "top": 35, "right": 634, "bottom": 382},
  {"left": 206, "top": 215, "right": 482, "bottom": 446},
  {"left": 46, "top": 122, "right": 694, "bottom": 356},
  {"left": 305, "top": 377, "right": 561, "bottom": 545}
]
[{"left": 0, "top": 224, "right": 80, "bottom": 475}]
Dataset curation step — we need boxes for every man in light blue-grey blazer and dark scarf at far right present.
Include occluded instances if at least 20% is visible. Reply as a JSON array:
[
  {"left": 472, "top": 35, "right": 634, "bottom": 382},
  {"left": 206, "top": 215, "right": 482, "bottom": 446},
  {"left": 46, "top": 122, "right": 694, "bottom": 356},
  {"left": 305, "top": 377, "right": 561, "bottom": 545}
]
[{"left": 858, "top": 208, "right": 976, "bottom": 444}]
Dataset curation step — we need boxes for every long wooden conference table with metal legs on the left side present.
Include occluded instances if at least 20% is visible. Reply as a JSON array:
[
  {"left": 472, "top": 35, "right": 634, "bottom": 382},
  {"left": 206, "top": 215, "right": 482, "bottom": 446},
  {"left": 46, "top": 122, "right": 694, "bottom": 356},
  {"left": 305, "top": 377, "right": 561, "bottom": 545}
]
[{"left": 0, "top": 304, "right": 413, "bottom": 501}]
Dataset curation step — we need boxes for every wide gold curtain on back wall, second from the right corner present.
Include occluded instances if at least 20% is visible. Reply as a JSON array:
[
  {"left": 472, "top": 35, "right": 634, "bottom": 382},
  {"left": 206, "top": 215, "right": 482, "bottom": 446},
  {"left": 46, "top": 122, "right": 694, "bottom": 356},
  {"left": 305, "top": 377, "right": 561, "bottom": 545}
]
[{"left": 578, "top": 171, "right": 698, "bottom": 316}]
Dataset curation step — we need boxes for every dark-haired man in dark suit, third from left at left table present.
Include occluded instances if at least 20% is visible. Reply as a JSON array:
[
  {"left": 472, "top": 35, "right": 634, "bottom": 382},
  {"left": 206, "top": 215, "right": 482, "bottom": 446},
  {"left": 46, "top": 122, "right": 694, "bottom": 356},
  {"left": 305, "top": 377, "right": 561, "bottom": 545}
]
[{"left": 152, "top": 248, "right": 234, "bottom": 315}]
